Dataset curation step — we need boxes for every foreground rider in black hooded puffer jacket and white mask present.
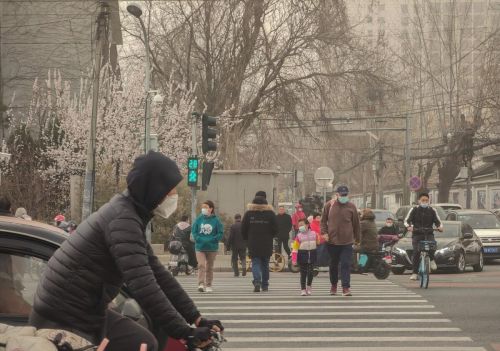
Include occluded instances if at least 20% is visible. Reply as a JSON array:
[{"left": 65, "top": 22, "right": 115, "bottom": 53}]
[{"left": 30, "top": 151, "right": 222, "bottom": 351}]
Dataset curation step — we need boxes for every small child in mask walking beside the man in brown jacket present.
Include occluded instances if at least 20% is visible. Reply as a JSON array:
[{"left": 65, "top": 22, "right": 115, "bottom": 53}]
[{"left": 292, "top": 219, "right": 320, "bottom": 296}]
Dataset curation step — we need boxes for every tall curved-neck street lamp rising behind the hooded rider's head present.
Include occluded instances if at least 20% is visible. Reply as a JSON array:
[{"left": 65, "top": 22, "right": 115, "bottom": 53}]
[{"left": 127, "top": 4, "right": 151, "bottom": 153}]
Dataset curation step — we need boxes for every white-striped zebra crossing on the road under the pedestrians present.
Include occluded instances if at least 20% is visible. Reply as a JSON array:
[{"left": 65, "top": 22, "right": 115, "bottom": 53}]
[{"left": 178, "top": 273, "right": 486, "bottom": 351}]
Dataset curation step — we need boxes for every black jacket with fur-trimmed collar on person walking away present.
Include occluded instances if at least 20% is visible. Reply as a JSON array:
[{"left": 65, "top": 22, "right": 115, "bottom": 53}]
[{"left": 241, "top": 198, "right": 278, "bottom": 257}]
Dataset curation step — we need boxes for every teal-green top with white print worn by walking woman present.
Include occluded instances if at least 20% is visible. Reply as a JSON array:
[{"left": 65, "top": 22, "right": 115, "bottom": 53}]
[{"left": 191, "top": 215, "right": 224, "bottom": 252}]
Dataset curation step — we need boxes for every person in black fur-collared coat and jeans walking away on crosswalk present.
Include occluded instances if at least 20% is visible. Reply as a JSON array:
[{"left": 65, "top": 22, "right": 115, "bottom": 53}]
[{"left": 241, "top": 196, "right": 278, "bottom": 292}]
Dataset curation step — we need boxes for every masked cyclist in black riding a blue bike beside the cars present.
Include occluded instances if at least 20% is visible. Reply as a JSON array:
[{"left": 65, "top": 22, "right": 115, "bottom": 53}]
[{"left": 404, "top": 193, "right": 443, "bottom": 280}]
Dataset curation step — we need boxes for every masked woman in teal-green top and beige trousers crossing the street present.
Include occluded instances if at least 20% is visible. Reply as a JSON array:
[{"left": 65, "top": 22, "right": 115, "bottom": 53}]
[{"left": 191, "top": 200, "right": 224, "bottom": 293}]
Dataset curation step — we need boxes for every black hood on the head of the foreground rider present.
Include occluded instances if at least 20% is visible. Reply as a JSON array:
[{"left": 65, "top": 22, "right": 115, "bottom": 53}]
[{"left": 127, "top": 151, "right": 182, "bottom": 213}]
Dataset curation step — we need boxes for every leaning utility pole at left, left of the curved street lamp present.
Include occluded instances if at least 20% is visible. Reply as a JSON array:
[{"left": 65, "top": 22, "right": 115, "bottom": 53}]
[{"left": 82, "top": 1, "right": 109, "bottom": 221}]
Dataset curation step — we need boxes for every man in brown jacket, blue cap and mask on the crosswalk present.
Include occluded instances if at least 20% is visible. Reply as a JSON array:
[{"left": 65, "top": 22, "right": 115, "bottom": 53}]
[{"left": 321, "top": 185, "right": 360, "bottom": 296}]
